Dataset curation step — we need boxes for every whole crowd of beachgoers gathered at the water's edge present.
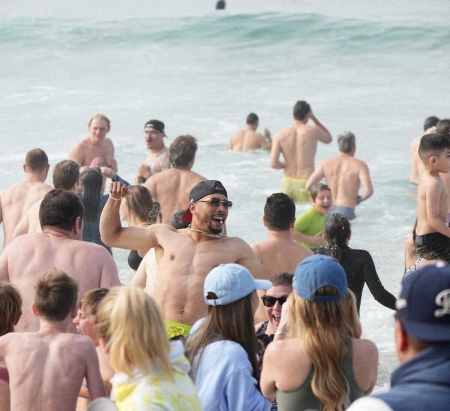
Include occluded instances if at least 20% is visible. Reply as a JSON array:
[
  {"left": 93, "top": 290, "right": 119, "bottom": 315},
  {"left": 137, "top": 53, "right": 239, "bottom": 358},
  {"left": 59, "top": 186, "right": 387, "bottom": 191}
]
[{"left": 0, "top": 107, "right": 450, "bottom": 411}]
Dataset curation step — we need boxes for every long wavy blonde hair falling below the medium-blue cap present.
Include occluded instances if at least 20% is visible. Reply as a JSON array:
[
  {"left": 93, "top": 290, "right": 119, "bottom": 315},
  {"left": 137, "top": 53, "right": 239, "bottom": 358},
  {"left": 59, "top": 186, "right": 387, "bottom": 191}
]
[{"left": 289, "top": 287, "right": 361, "bottom": 411}]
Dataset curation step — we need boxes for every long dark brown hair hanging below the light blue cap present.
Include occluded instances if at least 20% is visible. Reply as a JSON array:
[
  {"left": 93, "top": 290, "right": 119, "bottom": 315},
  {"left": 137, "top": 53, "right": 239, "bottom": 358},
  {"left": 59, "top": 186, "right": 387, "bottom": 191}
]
[{"left": 186, "top": 292, "right": 259, "bottom": 382}]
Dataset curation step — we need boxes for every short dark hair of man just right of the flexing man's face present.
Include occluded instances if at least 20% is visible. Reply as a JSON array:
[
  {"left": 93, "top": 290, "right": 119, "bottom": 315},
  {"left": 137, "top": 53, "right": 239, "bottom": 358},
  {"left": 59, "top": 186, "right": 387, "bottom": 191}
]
[{"left": 264, "top": 193, "right": 295, "bottom": 231}]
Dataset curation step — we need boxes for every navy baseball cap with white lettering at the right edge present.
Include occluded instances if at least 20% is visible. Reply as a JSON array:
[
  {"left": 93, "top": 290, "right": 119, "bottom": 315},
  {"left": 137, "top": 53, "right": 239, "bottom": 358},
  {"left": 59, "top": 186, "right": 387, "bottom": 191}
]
[{"left": 395, "top": 262, "right": 450, "bottom": 342}]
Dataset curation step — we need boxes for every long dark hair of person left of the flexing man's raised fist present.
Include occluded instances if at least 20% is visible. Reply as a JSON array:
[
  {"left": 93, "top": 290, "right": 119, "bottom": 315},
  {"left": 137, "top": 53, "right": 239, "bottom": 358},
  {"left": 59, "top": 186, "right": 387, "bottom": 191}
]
[{"left": 78, "top": 168, "right": 103, "bottom": 223}]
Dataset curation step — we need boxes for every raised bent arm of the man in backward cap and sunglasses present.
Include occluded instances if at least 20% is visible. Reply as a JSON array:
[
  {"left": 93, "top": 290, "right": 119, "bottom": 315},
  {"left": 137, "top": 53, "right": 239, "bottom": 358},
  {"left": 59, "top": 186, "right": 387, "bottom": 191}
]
[{"left": 100, "top": 182, "right": 158, "bottom": 250}]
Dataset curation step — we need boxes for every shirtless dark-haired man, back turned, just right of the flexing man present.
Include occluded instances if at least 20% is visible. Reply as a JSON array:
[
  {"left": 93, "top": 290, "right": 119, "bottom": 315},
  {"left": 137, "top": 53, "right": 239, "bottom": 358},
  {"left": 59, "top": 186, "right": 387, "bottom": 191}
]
[{"left": 251, "top": 193, "right": 313, "bottom": 324}]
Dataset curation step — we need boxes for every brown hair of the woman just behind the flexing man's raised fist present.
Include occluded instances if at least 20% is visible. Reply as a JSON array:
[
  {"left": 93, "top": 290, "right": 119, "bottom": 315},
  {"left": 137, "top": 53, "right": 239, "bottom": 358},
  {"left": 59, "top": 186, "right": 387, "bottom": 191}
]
[{"left": 125, "top": 185, "right": 162, "bottom": 224}]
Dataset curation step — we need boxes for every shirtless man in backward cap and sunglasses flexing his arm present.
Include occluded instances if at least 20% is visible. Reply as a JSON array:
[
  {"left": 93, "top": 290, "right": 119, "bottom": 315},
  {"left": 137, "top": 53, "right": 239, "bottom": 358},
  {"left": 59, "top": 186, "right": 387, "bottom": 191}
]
[{"left": 100, "top": 180, "right": 271, "bottom": 335}]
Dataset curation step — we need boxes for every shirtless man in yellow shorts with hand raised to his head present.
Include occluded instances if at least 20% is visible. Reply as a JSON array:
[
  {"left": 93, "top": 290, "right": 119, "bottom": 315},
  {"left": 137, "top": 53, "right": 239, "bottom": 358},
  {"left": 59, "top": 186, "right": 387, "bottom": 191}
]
[{"left": 270, "top": 101, "right": 332, "bottom": 204}]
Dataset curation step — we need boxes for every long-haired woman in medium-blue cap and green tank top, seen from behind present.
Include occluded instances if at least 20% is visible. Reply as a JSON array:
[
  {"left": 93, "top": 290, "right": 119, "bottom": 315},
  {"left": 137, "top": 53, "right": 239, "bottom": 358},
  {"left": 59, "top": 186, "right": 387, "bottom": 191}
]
[{"left": 261, "top": 255, "right": 378, "bottom": 411}]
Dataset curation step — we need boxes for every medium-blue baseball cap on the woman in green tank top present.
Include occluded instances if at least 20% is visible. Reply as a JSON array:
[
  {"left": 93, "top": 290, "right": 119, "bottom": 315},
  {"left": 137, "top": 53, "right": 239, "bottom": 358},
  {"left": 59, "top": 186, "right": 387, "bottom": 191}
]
[{"left": 293, "top": 254, "right": 347, "bottom": 302}]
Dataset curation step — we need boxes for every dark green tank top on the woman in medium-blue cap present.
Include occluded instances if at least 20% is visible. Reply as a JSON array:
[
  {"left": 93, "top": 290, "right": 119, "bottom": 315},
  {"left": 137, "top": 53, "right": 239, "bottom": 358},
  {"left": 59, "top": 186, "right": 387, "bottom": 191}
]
[{"left": 277, "top": 352, "right": 364, "bottom": 411}]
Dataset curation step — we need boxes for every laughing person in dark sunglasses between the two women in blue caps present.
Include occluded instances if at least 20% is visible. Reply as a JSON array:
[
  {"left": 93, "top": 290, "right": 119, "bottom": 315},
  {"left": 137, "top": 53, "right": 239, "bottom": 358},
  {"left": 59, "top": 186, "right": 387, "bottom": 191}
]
[{"left": 255, "top": 273, "right": 294, "bottom": 347}]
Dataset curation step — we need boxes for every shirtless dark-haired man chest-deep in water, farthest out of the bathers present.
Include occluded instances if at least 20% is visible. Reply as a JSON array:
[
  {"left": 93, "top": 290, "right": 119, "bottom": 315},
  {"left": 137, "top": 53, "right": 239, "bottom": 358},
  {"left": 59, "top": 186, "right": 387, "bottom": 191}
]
[{"left": 227, "top": 113, "right": 272, "bottom": 151}]
